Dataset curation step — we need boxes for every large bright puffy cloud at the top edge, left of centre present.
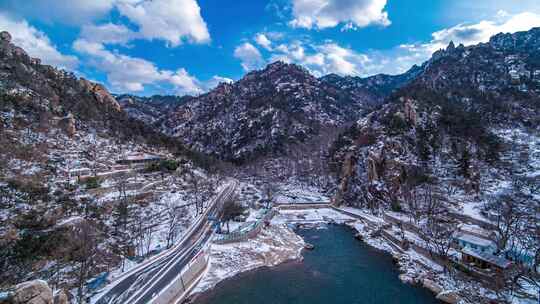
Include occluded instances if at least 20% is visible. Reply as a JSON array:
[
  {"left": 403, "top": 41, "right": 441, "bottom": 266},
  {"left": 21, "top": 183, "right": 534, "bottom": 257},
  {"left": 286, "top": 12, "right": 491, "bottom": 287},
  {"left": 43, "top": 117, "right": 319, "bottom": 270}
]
[{"left": 117, "top": 0, "right": 210, "bottom": 46}]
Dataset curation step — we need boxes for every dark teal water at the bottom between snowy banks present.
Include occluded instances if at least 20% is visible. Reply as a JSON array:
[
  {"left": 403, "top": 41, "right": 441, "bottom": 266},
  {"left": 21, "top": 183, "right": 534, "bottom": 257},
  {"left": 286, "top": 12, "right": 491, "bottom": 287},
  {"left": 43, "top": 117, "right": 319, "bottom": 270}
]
[{"left": 196, "top": 225, "right": 440, "bottom": 304}]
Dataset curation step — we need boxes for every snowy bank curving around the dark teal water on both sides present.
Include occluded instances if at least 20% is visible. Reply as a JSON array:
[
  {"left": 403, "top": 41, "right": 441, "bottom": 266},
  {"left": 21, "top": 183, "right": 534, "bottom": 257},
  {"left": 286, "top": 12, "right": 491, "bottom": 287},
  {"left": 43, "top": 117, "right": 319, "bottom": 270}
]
[{"left": 189, "top": 208, "right": 529, "bottom": 303}]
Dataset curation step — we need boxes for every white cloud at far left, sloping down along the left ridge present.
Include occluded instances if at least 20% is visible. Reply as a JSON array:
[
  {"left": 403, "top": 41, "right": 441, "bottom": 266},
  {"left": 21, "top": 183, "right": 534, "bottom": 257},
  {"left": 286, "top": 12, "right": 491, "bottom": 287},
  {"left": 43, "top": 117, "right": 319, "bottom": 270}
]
[{"left": 0, "top": 13, "right": 78, "bottom": 69}]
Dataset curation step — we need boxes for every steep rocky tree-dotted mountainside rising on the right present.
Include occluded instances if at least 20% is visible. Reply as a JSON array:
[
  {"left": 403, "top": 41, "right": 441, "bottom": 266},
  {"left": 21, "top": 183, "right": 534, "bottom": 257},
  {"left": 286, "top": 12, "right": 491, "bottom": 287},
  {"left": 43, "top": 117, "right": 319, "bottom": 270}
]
[{"left": 331, "top": 29, "right": 540, "bottom": 206}]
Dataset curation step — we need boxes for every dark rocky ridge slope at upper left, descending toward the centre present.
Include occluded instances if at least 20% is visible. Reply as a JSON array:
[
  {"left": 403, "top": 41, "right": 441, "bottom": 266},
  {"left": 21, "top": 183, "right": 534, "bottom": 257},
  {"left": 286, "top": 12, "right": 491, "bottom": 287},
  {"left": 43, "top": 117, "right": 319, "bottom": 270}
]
[{"left": 0, "top": 32, "right": 191, "bottom": 149}]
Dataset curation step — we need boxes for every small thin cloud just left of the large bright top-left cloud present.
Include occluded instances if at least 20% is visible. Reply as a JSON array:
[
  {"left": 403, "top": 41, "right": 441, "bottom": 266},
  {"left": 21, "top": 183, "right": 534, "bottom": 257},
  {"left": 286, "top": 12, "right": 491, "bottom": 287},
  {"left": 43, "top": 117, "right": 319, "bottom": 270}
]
[{"left": 80, "top": 23, "right": 137, "bottom": 44}]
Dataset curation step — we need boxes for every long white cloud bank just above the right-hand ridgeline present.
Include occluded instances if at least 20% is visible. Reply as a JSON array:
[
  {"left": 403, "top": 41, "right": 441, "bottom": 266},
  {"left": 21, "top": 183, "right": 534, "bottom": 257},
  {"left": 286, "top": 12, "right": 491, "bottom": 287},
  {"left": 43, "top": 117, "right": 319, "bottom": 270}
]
[{"left": 269, "top": 12, "right": 540, "bottom": 77}]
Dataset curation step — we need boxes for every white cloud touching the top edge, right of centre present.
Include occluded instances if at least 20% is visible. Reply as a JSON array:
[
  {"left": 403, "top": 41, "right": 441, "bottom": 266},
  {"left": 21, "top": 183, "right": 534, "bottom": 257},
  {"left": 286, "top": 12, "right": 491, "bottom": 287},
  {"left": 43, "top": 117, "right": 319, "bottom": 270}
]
[{"left": 290, "top": 0, "right": 390, "bottom": 29}]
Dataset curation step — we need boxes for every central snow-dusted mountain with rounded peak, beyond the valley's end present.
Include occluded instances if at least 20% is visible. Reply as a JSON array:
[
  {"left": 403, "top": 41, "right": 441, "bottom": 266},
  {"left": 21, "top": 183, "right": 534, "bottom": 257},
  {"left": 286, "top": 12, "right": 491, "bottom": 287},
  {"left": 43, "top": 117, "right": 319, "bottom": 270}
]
[{"left": 158, "top": 62, "right": 386, "bottom": 162}]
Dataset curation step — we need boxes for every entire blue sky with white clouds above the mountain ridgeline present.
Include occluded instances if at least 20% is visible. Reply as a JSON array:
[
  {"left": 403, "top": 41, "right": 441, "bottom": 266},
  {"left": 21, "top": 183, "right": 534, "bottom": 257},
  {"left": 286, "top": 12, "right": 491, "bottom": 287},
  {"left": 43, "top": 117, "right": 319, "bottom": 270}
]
[{"left": 0, "top": 0, "right": 540, "bottom": 95}]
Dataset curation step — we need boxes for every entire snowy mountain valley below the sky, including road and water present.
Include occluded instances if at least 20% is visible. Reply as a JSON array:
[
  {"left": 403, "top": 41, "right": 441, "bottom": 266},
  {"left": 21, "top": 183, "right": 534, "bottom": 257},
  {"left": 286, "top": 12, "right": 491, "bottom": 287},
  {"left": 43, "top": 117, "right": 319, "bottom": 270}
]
[{"left": 0, "top": 22, "right": 540, "bottom": 304}]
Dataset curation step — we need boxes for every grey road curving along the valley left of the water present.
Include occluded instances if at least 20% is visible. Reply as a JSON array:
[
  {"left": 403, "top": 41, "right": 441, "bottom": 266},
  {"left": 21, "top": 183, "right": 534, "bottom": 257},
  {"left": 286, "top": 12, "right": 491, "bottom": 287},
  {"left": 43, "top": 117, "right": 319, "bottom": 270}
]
[{"left": 95, "top": 181, "right": 237, "bottom": 304}]
